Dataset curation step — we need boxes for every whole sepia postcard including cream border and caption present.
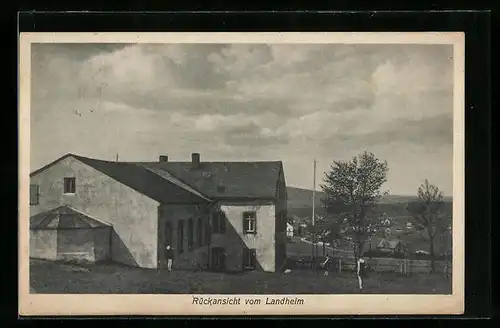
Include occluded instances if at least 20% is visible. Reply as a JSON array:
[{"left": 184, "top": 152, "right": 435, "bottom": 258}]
[{"left": 19, "top": 33, "right": 464, "bottom": 314}]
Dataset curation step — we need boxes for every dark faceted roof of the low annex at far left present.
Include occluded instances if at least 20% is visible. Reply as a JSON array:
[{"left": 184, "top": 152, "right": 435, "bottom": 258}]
[{"left": 30, "top": 205, "right": 111, "bottom": 230}]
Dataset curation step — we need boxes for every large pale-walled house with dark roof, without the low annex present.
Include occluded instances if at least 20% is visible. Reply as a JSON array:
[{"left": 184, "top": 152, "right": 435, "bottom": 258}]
[{"left": 30, "top": 154, "right": 287, "bottom": 272}]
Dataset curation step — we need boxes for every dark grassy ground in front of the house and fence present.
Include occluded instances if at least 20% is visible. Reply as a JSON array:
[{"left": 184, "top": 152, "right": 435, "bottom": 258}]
[{"left": 30, "top": 260, "right": 451, "bottom": 294}]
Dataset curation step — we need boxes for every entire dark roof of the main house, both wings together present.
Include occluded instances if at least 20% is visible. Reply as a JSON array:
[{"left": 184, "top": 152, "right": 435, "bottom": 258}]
[{"left": 30, "top": 154, "right": 283, "bottom": 204}]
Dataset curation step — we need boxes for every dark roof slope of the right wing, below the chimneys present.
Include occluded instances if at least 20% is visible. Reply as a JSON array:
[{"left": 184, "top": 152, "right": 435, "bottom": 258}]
[{"left": 140, "top": 161, "right": 282, "bottom": 199}]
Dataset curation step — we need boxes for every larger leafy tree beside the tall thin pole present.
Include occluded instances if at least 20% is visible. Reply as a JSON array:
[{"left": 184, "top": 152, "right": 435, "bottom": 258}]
[{"left": 321, "top": 151, "right": 388, "bottom": 261}]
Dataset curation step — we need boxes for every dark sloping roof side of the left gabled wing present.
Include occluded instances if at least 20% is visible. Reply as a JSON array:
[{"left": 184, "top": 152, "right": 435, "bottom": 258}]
[{"left": 73, "top": 155, "right": 206, "bottom": 204}]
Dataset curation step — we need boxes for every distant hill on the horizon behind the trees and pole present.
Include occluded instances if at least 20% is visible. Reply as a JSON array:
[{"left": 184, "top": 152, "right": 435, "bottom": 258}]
[{"left": 287, "top": 187, "right": 453, "bottom": 220}]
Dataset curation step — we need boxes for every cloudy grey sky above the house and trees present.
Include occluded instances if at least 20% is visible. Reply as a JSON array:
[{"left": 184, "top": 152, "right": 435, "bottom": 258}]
[{"left": 31, "top": 44, "right": 453, "bottom": 195}]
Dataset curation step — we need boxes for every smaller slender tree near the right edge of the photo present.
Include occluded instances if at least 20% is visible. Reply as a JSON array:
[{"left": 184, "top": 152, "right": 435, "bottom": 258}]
[{"left": 407, "top": 179, "right": 447, "bottom": 272}]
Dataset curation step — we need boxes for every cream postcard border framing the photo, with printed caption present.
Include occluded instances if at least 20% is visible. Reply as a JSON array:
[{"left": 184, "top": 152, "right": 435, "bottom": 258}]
[{"left": 18, "top": 32, "right": 465, "bottom": 316}]
